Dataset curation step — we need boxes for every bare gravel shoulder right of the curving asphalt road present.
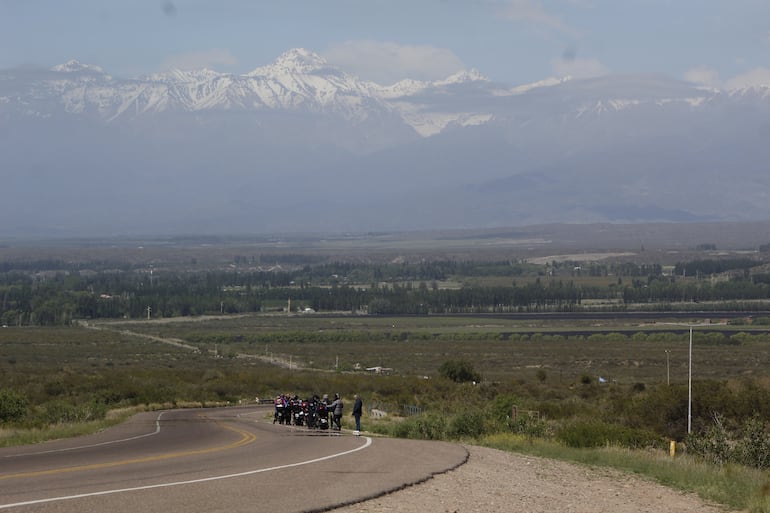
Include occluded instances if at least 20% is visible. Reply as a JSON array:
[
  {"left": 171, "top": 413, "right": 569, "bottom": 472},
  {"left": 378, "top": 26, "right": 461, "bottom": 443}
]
[{"left": 334, "top": 446, "right": 727, "bottom": 513}]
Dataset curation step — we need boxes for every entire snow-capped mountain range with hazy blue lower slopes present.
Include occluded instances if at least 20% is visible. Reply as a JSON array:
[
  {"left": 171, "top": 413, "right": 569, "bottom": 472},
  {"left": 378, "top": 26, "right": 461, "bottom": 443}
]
[{"left": 0, "top": 49, "right": 770, "bottom": 235}]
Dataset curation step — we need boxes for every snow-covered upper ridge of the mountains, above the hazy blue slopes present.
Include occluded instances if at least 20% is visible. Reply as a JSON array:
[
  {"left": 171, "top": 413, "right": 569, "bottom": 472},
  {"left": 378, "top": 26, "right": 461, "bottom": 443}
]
[{"left": 0, "top": 48, "right": 756, "bottom": 137}]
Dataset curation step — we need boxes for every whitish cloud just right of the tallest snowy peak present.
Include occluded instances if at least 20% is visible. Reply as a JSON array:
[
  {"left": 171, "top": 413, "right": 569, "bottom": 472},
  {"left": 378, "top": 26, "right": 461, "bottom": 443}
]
[{"left": 323, "top": 41, "right": 465, "bottom": 84}]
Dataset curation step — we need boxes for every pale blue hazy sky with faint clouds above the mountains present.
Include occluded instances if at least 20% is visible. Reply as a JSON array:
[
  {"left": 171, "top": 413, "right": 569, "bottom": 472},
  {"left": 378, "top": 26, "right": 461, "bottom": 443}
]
[{"left": 0, "top": 0, "right": 770, "bottom": 87}]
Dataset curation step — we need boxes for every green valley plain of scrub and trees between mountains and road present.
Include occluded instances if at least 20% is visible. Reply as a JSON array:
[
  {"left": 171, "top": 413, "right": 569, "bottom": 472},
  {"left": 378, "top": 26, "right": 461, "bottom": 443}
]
[{"left": 0, "top": 243, "right": 770, "bottom": 512}]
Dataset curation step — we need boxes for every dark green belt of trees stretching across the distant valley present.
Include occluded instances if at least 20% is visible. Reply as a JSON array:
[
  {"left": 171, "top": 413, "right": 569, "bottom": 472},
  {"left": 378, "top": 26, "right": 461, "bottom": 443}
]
[{"left": 0, "top": 261, "right": 770, "bottom": 325}]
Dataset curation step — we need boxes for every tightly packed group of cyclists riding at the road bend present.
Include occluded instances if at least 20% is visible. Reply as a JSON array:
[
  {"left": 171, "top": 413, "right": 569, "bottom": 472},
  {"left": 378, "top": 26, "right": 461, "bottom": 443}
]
[{"left": 273, "top": 394, "right": 343, "bottom": 431}]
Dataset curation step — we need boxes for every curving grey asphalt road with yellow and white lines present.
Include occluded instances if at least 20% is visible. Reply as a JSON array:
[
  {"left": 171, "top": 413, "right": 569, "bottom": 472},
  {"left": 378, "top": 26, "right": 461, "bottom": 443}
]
[{"left": 0, "top": 406, "right": 468, "bottom": 513}]
